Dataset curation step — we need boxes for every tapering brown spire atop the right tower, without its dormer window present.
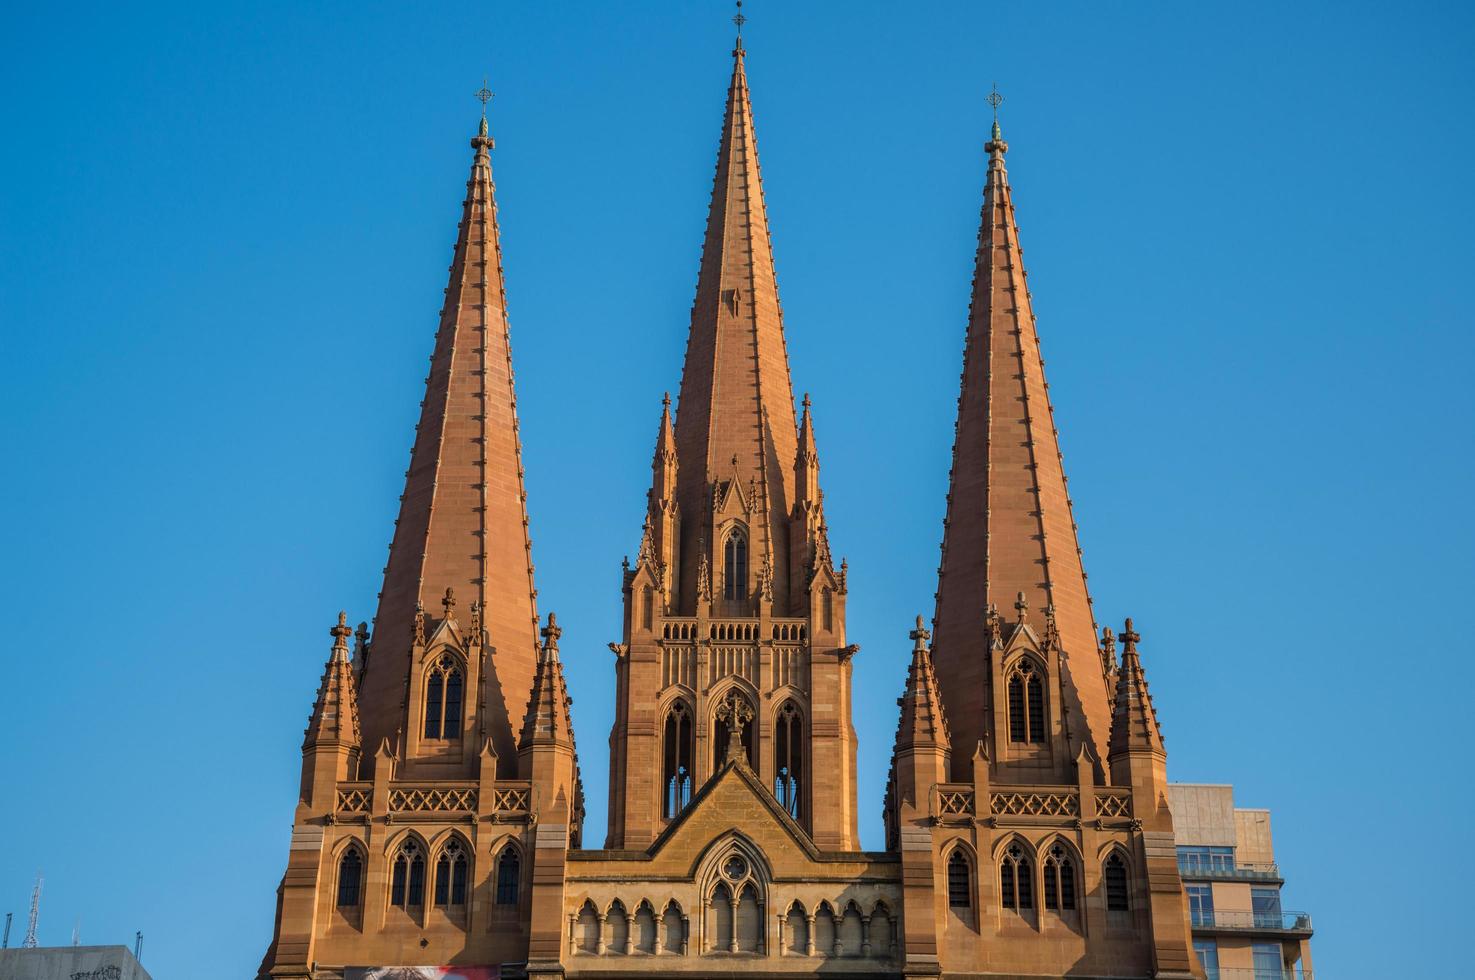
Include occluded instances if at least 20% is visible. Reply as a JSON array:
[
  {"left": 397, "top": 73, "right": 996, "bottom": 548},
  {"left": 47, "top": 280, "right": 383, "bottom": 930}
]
[{"left": 934, "top": 110, "right": 1111, "bottom": 778}]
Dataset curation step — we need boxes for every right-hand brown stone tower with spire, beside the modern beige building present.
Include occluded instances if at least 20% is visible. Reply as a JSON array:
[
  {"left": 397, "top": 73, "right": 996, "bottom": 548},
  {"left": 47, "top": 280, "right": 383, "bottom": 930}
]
[{"left": 886, "top": 120, "right": 1201, "bottom": 977}]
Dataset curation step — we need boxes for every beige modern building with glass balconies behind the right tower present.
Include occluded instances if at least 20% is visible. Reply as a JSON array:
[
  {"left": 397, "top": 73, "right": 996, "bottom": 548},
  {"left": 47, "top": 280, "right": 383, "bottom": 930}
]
[{"left": 1168, "top": 782, "right": 1311, "bottom": 980}]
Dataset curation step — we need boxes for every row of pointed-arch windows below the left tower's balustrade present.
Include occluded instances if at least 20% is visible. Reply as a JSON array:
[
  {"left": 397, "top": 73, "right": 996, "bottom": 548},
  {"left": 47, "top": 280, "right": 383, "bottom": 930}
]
[{"left": 332, "top": 832, "right": 524, "bottom": 924}]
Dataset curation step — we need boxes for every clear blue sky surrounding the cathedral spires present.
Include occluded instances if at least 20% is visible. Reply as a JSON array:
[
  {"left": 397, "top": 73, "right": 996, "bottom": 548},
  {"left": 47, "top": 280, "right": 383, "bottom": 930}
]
[{"left": 0, "top": 0, "right": 1475, "bottom": 980}]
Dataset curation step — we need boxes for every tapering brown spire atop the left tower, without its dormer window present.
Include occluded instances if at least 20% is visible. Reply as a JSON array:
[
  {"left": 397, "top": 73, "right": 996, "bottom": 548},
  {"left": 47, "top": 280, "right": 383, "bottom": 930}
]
[{"left": 361, "top": 118, "right": 538, "bottom": 760}]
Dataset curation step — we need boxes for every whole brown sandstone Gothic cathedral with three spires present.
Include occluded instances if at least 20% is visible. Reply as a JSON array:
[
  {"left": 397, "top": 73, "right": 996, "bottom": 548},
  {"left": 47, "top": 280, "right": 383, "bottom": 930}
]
[{"left": 258, "top": 30, "right": 1204, "bottom": 980}]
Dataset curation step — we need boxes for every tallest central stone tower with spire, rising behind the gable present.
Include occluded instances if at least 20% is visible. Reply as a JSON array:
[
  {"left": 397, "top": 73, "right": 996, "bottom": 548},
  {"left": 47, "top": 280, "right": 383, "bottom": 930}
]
[{"left": 608, "top": 36, "right": 858, "bottom": 849}]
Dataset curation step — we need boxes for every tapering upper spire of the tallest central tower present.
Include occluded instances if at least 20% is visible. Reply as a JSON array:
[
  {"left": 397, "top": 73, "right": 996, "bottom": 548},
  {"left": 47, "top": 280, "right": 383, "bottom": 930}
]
[{"left": 676, "top": 43, "right": 797, "bottom": 614}]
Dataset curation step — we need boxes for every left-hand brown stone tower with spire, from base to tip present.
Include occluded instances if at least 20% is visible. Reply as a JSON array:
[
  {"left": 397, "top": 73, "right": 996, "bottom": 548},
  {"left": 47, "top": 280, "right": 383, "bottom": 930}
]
[{"left": 261, "top": 110, "right": 583, "bottom": 979}]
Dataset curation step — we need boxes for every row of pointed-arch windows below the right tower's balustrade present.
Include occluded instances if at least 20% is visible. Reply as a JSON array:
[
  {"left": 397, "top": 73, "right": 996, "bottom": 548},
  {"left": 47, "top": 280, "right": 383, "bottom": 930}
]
[{"left": 944, "top": 837, "right": 1133, "bottom": 925}]
